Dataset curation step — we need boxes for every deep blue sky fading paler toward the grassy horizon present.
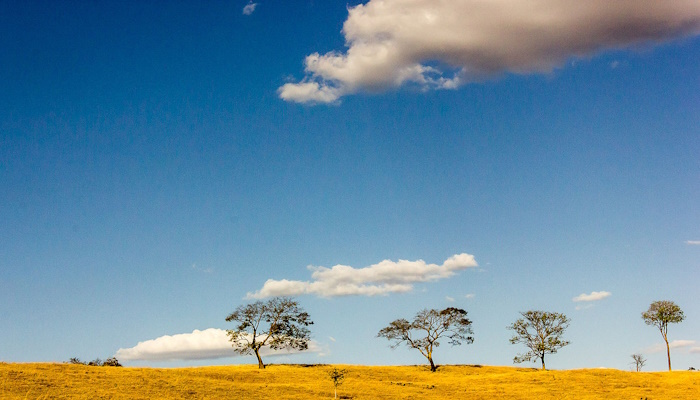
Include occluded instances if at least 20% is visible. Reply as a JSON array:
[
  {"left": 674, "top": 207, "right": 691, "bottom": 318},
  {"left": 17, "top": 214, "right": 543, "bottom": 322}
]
[{"left": 0, "top": 0, "right": 700, "bottom": 370}]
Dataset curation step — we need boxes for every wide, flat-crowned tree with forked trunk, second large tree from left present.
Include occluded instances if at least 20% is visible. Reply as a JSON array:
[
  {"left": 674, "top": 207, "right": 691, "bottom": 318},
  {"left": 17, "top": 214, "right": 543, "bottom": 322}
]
[{"left": 377, "top": 307, "right": 474, "bottom": 372}]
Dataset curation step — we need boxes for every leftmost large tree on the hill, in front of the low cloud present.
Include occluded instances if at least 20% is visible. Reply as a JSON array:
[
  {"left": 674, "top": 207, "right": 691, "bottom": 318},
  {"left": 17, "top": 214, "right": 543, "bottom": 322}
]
[{"left": 226, "top": 297, "right": 313, "bottom": 369}]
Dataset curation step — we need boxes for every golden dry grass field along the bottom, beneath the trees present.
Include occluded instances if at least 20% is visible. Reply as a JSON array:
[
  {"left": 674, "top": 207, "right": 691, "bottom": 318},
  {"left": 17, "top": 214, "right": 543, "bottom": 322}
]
[{"left": 0, "top": 363, "right": 700, "bottom": 400}]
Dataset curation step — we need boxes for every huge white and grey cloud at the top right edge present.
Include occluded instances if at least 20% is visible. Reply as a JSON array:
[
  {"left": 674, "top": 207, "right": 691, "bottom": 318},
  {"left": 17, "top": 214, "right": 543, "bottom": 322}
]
[{"left": 279, "top": 0, "right": 700, "bottom": 103}]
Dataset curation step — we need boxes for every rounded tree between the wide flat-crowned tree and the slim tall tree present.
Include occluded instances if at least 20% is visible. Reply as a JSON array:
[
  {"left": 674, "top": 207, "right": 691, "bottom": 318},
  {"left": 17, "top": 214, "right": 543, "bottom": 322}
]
[{"left": 508, "top": 311, "right": 570, "bottom": 370}]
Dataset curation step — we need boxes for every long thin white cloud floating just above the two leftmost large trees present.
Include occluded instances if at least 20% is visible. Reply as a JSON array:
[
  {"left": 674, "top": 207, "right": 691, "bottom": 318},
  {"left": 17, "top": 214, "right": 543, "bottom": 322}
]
[{"left": 247, "top": 253, "right": 478, "bottom": 298}]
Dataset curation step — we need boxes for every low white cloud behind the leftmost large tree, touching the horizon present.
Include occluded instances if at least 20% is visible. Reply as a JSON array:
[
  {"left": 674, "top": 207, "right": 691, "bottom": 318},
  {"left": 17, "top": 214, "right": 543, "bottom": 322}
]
[{"left": 115, "top": 328, "right": 320, "bottom": 361}]
